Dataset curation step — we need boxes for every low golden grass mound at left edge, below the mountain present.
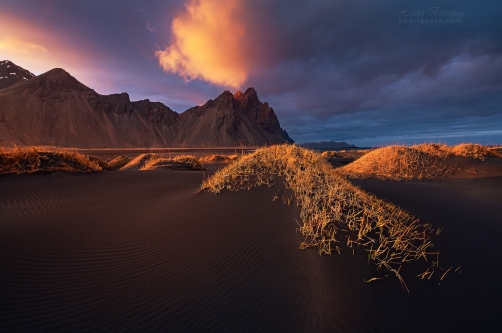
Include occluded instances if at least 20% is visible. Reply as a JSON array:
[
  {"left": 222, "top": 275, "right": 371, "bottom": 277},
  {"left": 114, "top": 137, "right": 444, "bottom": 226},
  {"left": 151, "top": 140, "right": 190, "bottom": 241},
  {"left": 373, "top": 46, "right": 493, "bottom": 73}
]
[{"left": 0, "top": 147, "right": 104, "bottom": 174}]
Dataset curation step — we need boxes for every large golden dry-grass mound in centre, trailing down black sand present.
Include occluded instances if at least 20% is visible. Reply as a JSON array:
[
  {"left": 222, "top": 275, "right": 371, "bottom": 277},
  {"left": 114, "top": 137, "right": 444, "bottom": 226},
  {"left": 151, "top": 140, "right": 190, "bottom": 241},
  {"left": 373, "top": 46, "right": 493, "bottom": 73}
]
[{"left": 201, "top": 145, "right": 439, "bottom": 288}]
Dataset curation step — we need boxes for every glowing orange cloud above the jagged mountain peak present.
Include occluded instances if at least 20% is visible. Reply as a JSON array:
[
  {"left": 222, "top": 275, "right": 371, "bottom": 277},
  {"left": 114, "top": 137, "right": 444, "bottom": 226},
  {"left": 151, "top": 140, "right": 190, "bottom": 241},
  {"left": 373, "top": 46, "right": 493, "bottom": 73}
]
[{"left": 155, "top": 0, "right": 249, "bottom": 89}]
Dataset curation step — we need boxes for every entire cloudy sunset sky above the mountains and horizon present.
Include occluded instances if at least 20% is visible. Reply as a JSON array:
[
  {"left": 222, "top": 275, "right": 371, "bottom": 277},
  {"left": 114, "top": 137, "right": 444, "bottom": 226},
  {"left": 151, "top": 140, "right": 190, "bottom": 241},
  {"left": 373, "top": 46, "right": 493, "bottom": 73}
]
[{"left": 0, "top": 0, "right": 502, "bottom": 146}]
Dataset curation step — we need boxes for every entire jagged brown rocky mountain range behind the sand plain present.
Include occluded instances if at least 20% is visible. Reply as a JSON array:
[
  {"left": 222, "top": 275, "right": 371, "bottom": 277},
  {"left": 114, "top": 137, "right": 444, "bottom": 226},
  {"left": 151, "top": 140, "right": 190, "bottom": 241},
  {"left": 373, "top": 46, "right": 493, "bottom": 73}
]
[{"left": 0, "top": 64, "right": 292, "bottom": 148}]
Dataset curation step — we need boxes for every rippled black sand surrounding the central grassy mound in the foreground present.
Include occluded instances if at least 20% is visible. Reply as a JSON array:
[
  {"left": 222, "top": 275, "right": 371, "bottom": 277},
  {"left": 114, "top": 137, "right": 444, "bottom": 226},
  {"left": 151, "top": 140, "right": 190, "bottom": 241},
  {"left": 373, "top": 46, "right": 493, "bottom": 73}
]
[{"left": 0, "top": 170, "right": 502, "bottom": 332}]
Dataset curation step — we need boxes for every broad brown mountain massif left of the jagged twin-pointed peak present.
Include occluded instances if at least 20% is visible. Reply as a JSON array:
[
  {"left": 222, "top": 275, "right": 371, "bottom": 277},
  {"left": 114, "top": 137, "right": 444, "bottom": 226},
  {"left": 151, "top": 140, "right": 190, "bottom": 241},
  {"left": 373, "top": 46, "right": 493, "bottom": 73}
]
[{"left": 0, "top": 69, "right": 179, "bottom": 147}]
